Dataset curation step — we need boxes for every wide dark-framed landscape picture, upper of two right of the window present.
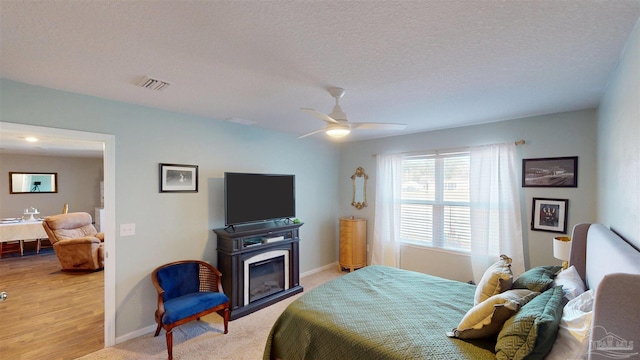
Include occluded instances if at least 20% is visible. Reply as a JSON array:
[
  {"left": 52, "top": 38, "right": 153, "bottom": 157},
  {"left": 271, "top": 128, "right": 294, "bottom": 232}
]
[{"left": 522, "top": 156, "right": 578, "bottom": 187}]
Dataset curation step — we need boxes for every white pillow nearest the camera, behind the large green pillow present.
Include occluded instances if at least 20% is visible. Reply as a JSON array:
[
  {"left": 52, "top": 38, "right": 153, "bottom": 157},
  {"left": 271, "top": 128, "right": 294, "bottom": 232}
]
[{"left": 545, "top": 290, "right": 593, "bottom": 360}]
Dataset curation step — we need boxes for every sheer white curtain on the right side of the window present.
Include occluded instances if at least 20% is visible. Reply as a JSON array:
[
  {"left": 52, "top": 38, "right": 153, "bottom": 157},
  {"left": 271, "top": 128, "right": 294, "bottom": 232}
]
[{"left": 470, "top": 143, "right": 524, "bottom": 283}]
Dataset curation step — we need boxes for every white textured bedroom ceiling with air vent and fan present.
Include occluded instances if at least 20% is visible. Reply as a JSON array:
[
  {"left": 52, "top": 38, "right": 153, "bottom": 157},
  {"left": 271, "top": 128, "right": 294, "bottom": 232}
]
[{"left": 0, "top": 0, "right": 640, "bottom": 152}]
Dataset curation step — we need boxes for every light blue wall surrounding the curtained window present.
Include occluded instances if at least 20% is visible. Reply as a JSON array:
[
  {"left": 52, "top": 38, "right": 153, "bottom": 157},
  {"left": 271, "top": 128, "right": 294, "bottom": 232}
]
[{"left": 340, "top": 110, "right": 597, "bottom": 281}]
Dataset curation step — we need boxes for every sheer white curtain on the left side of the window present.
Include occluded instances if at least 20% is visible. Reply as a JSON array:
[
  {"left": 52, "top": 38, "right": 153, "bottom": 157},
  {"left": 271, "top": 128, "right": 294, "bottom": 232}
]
[{"left": 371, "top": 154, "right": 403, "bottom": 267}]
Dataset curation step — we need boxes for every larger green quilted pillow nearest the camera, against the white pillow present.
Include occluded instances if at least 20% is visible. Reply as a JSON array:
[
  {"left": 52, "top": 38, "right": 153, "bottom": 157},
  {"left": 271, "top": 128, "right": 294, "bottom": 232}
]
[{"left": 495, "top": 286, "right": 562, "bottom": 360}]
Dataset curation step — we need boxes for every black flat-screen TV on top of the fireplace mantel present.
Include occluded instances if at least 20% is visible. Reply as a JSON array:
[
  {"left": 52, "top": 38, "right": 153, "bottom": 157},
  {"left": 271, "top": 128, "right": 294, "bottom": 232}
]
[{"left": 224, "top": 172, "right": 296, "bottom": 226}]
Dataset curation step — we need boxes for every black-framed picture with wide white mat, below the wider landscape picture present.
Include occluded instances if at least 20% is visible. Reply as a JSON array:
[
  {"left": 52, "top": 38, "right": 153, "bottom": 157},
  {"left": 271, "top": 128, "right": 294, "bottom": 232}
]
[{"left": 531, "top": 198, "right": 569, "bottom": 234}]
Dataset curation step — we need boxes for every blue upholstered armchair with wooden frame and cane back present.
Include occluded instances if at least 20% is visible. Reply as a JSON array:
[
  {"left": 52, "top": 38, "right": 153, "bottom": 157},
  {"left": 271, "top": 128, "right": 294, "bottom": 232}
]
[{"left": 151, "top": 260, "right": 229, "bottom": 360}]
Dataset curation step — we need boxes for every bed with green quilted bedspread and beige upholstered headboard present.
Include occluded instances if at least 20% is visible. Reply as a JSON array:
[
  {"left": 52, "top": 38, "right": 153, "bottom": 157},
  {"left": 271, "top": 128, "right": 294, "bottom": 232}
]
[{"left": 264, "top": 224, "right": 640, "bottom": 360}]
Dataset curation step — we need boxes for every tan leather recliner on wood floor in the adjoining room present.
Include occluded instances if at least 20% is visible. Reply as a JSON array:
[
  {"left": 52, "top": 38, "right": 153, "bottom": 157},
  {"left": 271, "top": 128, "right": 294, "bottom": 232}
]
[{"left": 42, "top": 212, "right": 104, "bottom": 270}]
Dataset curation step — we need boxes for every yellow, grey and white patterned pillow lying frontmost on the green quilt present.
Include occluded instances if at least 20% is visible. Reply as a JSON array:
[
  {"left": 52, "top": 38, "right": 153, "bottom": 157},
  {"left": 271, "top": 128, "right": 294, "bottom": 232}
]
[{"left": 447, "top": 289, "right": 540, "bottom": 339}]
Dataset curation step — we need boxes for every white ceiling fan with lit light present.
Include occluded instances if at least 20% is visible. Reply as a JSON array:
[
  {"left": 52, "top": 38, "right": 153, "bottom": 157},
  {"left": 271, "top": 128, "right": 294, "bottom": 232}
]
[{"left": 298, "top": 88, "right": 407, "bottom": 139}]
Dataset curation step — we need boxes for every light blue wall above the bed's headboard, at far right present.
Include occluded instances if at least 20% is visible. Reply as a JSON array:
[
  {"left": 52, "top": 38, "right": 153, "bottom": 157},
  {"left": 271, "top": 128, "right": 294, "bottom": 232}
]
[{"left": 598, "top": 20, "right": 640, "bottom": 248}]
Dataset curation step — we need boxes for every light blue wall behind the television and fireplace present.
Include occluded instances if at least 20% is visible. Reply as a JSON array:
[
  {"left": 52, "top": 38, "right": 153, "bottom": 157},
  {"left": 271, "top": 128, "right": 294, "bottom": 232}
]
[{"left": 0, "top": 79, "right": 340, "bottom": 337}]
